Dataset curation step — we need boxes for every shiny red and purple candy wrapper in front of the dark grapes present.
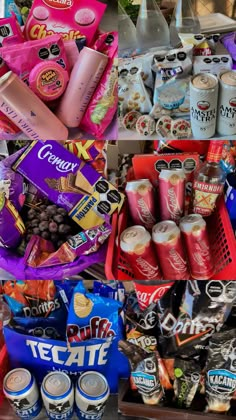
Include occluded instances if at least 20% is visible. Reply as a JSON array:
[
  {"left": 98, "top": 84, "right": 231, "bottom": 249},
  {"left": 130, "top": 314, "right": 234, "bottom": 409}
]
[{"left": 24, "top": 223, "right": 111, "bottom": 267}]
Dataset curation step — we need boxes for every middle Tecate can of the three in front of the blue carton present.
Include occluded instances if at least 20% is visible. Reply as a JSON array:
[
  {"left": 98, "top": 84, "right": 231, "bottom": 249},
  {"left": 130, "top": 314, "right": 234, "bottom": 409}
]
[{"left": 41, "top": 371, "right": 74, "bottom": 420}]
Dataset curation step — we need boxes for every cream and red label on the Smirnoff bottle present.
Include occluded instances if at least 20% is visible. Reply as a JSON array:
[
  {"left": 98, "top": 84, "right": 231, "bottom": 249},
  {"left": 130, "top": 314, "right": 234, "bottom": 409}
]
[{"left": 193, "top": 181, "right": 224, "bottom": 216}]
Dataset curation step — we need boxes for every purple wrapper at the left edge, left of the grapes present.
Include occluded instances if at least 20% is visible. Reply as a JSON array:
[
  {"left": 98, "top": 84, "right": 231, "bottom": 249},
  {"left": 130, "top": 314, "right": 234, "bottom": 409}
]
[{"left": 0, "top": 192, "right": 25, "bottom": 248}]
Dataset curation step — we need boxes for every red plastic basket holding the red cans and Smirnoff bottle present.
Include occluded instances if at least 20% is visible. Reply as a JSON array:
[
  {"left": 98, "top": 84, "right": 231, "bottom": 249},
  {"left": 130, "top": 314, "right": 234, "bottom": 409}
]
[{"left": 105, "top": 197, "right": 236, "bottom": 280}]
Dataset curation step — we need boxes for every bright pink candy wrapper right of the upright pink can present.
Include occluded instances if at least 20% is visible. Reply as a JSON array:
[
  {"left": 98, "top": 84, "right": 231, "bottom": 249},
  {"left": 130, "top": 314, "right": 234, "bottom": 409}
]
[{"left": 80, "top": 32, "right": 118, "bottom": 138}]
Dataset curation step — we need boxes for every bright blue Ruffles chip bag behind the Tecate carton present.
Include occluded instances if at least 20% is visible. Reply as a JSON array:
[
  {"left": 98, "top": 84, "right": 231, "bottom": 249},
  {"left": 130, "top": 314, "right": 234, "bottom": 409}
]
[{"left": 67, "top": 282, "right": 122, "bottom": 347}]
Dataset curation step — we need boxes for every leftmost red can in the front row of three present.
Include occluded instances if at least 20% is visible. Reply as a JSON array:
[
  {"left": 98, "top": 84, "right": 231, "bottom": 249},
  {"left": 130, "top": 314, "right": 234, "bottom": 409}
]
[{"left": 120, "top": 226, "right": 161, "bottom": 280}]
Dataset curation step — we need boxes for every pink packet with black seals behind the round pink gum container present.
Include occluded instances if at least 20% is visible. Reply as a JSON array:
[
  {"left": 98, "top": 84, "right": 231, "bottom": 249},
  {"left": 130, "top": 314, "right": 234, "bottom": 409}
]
[{"left": 0, "top": 35, "right": 69, "bottom": 84}]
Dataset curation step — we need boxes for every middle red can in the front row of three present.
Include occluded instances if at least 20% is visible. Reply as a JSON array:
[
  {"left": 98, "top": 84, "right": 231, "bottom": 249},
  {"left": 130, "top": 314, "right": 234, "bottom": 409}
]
[{"left": 152, "top": 220, "right": 190, "bottom": 280}]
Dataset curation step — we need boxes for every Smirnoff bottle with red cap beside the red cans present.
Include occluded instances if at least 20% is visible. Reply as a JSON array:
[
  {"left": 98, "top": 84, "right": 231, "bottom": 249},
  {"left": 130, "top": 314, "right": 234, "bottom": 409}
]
[{"left": 193, "top": 140, "right": 226, "bottom": 217}]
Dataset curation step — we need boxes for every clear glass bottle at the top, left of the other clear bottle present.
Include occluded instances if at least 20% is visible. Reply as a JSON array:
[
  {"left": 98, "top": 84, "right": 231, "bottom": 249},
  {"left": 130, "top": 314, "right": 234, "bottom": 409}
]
[{"left": 136, "top": 0, "right": 170, "bottom": 52}]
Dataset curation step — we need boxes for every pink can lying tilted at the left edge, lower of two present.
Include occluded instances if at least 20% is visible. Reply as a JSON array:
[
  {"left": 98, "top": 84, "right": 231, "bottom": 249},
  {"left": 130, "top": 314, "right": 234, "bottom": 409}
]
[{"left": 0, "top": 71, "right": 68, "bottom": 141}]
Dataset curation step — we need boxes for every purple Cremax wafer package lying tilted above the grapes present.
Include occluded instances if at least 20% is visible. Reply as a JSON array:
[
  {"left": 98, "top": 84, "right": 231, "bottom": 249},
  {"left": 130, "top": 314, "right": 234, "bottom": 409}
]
[{"left": 13, "top": 141, "right": 124, "bottom": 229}]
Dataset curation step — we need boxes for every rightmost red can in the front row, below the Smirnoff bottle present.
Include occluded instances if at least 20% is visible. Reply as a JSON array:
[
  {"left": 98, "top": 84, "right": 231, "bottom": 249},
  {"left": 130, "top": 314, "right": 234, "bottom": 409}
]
[{"left": 180, "top": 214, "right": 214, "bottom": 280}]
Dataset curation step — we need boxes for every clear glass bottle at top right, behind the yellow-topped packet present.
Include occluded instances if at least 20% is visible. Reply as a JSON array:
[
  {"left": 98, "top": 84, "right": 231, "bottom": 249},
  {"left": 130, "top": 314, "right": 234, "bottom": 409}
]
[{"left": 170, "top": 0, "right": 201, "bottom": 47}]
